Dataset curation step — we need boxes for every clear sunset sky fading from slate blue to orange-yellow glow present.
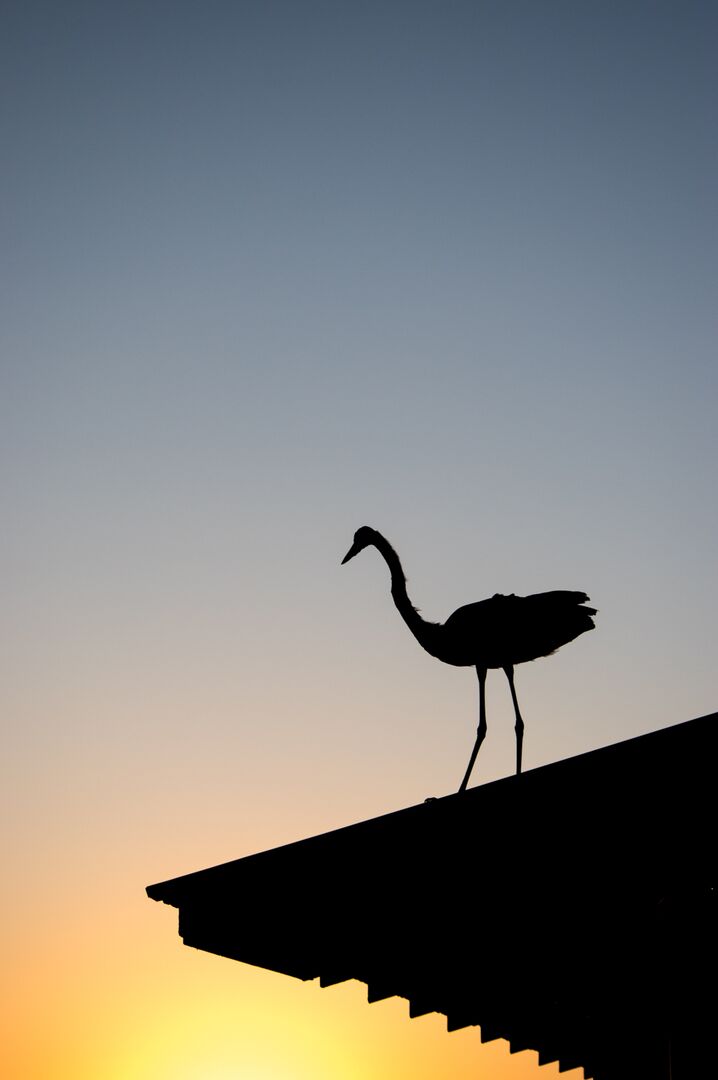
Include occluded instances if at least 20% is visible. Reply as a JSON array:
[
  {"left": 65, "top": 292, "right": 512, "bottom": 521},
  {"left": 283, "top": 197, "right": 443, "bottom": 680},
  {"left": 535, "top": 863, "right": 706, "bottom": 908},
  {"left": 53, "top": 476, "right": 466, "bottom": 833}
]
[{"left": 0, "top": 0, "right": 718, "bottom": 1080}]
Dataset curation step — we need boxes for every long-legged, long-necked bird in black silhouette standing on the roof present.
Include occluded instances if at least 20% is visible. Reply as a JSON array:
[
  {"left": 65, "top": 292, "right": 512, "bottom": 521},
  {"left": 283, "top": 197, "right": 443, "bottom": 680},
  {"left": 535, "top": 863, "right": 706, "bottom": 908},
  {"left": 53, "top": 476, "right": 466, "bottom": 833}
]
[{"left": 341, "top": 525, "right": 596, "bottom": 792}]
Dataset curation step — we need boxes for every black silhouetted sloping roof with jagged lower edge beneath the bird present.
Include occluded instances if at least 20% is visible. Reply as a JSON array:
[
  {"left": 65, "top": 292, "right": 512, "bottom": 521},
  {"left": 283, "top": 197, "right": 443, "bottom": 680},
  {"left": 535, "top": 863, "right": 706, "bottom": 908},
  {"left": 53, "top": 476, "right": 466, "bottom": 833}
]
[{"left": 147, "top": 714, "right": 718, "bottom": 1080}]
